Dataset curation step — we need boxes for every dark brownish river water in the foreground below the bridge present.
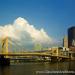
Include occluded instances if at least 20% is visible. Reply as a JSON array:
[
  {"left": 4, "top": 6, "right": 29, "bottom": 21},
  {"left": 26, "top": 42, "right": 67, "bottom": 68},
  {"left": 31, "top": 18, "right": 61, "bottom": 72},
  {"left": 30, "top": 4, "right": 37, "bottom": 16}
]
[{"left": 0, "top": 61, "right": 75, "bottom": 75}]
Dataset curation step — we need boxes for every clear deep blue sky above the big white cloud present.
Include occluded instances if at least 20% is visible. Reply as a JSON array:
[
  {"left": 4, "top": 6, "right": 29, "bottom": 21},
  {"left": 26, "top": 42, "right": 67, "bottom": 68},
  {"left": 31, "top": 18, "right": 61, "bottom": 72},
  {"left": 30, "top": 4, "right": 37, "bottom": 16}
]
[{"left": 0, "top": 0, "right": 75, "bottom": 39}]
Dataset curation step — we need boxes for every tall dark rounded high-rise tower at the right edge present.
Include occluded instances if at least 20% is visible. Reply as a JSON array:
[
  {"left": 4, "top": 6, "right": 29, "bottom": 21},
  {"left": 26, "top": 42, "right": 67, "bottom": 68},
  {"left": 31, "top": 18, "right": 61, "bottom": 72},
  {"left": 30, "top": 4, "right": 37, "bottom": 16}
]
[{"left": 68, "top": 26, "right": 75, "bottom": 48}]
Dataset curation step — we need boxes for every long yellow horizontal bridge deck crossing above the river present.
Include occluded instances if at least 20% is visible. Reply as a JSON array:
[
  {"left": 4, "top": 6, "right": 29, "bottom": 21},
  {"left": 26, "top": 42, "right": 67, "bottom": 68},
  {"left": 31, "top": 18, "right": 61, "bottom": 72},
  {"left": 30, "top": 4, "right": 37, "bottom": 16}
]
[{"left": 0, "top": 53, "right": 69, "bottom": 58}]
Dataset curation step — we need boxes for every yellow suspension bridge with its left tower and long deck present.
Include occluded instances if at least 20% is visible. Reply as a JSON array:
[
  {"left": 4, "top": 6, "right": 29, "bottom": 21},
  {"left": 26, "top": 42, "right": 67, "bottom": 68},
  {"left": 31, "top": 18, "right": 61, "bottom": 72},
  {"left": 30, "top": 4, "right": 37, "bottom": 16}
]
[{"left": 0, "top": 37, "right": 70, "bottom": 63}]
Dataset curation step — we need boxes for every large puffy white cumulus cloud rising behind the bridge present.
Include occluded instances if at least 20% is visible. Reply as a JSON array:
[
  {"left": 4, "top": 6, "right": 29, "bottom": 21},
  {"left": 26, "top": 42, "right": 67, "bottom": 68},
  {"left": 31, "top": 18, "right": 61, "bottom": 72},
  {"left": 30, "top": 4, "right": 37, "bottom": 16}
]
[{"left": 0, "top": 17, "right": 58, "bottom": 51}]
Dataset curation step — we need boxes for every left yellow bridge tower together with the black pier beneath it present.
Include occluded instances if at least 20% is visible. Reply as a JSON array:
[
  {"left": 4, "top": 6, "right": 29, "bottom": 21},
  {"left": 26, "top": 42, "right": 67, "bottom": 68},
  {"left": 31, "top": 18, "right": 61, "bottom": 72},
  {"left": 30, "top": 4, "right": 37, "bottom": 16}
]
[{"left": 0, "top": 37, "right": 10, "bottom": 66}]
